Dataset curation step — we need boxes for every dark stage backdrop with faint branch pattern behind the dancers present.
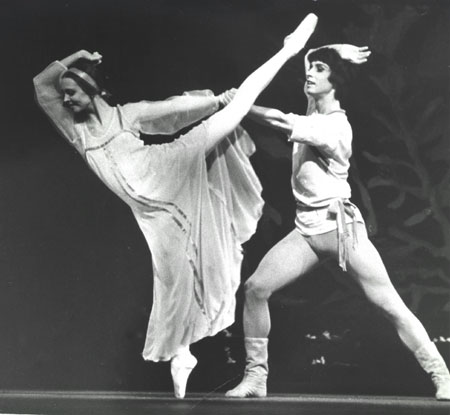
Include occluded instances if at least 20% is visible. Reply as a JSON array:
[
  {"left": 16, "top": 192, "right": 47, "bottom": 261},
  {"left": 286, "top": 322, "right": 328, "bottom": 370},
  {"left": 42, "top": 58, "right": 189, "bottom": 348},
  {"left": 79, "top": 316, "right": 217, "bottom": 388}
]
[{"left": 0, "top": 0, "right": 450, "bottom": 395}]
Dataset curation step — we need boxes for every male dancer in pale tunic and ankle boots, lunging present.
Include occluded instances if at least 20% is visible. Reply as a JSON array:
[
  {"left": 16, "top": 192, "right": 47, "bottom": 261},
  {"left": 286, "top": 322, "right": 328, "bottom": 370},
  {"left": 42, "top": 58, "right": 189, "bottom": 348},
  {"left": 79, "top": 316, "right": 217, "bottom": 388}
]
[{"left": 226, "top": 45, "right": 450, "bottom": 400}]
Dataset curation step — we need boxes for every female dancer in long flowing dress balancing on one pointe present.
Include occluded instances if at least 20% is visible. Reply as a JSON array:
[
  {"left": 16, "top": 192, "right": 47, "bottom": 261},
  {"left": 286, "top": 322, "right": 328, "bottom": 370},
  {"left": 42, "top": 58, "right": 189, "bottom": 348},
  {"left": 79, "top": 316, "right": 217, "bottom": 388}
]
[{"left": 34, "top": 15, "right": 317, "bottom": 398}]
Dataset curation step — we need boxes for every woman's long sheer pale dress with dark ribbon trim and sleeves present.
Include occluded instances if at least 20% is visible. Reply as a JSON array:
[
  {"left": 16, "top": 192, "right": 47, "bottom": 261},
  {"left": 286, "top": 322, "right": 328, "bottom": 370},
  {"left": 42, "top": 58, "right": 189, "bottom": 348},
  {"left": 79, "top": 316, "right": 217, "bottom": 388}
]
[{"left": 34, "top": 62, "right": 263, "bottom": 361}]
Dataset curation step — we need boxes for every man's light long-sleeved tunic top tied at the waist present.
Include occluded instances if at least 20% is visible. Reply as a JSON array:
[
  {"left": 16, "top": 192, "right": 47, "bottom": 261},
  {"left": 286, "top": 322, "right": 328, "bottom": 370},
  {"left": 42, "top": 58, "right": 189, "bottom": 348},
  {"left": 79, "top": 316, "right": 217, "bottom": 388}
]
[{"left": 289, "top": 110, "right": 363, "bottom": 235}]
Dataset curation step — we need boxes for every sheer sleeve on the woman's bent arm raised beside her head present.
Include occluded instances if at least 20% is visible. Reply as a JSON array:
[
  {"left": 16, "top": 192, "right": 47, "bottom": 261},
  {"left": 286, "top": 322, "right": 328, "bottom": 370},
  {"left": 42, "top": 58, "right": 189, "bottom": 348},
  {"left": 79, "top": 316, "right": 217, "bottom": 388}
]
[{"left": 33, "top": 61, "right": 80, "bottom": 151}]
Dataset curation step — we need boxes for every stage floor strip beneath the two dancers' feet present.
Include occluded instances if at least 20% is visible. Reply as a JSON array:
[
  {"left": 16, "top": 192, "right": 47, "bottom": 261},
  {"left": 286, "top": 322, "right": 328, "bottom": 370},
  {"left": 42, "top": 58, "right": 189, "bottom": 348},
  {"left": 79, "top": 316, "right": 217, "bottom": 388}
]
[{"left": 0, "top": 391, "right": 450, "bottom": 415}]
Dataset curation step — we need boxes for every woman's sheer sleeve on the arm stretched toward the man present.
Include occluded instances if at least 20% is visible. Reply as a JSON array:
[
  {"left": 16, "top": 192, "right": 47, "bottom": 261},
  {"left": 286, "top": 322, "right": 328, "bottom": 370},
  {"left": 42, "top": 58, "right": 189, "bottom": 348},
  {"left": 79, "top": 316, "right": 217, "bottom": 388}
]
[{"left": 119, "top": 90, "right": 219, "bottom": 135}]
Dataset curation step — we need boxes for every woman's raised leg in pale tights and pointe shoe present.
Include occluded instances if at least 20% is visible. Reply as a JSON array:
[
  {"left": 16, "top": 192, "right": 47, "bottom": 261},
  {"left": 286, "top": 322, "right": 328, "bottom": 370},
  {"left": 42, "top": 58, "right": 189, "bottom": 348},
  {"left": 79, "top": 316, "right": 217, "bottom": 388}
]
[{"left": 202, "top": 14, "right": 317, "bottom": 155}]
